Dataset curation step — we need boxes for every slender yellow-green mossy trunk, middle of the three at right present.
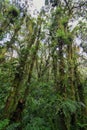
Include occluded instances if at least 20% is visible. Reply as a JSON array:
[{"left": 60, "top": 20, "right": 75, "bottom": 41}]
[{"left": 67, "top": 43, "right": 77, "bottom": 129}]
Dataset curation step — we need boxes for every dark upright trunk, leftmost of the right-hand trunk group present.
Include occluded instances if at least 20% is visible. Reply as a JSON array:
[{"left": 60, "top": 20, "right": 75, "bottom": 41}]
[{"left": 59, "top": 40, "right": 67, "bottom": 130}]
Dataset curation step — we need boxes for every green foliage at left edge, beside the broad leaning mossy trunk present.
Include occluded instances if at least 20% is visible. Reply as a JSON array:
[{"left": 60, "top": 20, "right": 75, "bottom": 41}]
[{"left": 0, "top": 61, "right": 16, "bottom": 115}]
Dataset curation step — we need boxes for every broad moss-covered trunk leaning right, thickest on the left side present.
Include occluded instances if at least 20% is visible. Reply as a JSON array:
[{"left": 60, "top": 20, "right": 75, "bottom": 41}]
[{"left": 3, "top": 17, "right": 41, "bottom": 122}]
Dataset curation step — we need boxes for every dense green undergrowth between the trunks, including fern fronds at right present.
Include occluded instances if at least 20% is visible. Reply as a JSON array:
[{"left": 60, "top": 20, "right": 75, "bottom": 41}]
[{"left": 22, "top": 81, "right": 84, "bottom": 130}]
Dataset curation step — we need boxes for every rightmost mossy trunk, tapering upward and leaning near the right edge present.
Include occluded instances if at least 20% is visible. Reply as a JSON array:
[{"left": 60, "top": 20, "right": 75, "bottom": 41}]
[{"left": 74, "top": 46, "right": 87, "bottom": 130}]
